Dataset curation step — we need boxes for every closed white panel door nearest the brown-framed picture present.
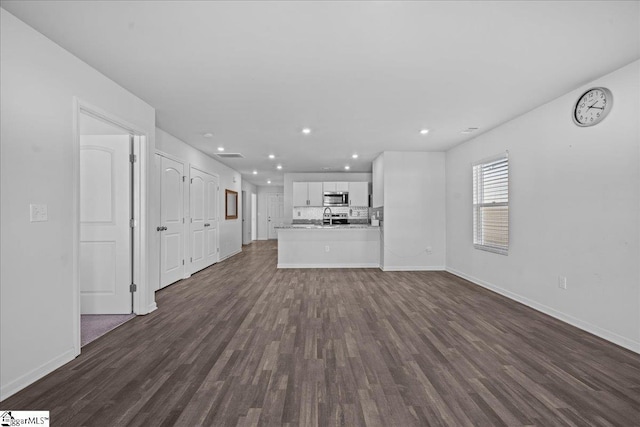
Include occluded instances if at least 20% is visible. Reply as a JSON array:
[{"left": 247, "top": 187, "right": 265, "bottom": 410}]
[{"left": 189, "top": 168, "right": 220, "bottom": 273}]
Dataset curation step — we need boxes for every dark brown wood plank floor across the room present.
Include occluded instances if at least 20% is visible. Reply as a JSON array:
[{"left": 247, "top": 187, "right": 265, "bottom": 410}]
[{"left": 0, "top": 242, "right": 640, "bottom": 426}]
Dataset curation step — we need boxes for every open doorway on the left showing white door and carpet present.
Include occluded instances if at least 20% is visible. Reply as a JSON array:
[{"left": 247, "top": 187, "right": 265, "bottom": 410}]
[{"left": 74, "top": 101, "right": 144, "bottom": 353}]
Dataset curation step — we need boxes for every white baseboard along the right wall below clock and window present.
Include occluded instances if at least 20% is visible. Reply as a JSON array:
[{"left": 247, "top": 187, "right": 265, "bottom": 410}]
[{"left": 446, "top": 268, "right": 640, "bottom": 353}]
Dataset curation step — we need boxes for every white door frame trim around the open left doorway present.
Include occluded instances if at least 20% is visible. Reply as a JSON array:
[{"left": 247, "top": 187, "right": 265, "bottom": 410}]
[{"left": 71, "top": 97, "right": 151, "bottom": 355}]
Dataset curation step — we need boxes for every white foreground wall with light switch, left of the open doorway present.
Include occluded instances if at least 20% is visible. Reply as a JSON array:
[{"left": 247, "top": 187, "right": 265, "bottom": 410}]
[{"left": 0, "top": 9, "right": 155, "bottom": 399}]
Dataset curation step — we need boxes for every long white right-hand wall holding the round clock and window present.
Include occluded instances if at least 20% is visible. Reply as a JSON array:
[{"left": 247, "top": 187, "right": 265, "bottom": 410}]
[{"left": 444, "top": 61, "right": 640, "bottom": 351}]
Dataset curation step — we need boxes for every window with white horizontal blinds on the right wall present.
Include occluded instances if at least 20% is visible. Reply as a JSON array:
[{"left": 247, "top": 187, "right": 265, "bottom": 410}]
[{"left": 473, "top": 153, "right": 509, "bottom": 255}]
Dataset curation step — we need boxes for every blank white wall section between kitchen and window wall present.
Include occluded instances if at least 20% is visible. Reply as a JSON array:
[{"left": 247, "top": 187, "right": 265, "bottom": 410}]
[{"left": 382, "top": 151, "right": 446, "bottom": 271}]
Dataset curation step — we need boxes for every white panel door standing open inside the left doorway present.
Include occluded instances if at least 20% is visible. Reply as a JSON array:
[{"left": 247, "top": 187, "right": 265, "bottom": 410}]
[{"left": 79, "top": 135, "right": 132, "bottom": 314}]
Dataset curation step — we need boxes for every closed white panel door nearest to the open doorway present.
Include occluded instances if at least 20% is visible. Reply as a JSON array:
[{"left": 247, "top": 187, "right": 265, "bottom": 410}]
[{"left": 157, "top": 156, "right": 184, "bottom": 288}]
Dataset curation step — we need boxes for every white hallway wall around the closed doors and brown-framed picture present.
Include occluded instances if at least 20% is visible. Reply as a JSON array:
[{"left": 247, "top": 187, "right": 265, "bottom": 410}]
[{"left": 152, "top": 128, "right": 242, "bottom": 262}]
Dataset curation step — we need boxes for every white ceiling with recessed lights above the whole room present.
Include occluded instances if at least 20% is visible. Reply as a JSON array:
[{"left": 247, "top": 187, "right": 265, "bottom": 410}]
[{"left": 2, "top": 1, "right": 640, "bottom": 185}]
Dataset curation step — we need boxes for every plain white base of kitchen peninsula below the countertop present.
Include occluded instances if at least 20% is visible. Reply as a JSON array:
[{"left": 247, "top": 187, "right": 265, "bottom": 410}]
[{"left": 277, "top": 225, "right": 380, "bottom": 268}]
